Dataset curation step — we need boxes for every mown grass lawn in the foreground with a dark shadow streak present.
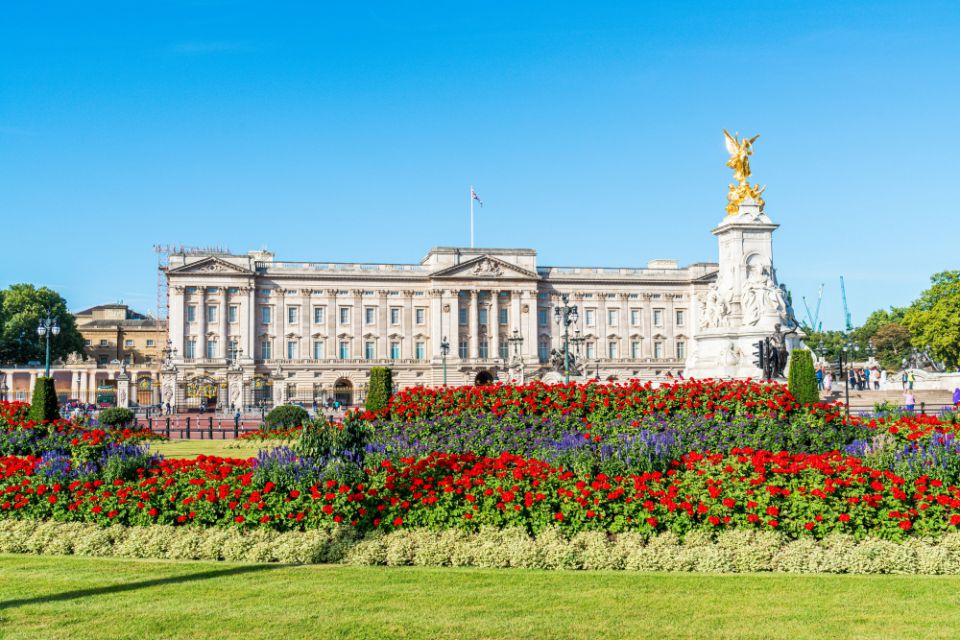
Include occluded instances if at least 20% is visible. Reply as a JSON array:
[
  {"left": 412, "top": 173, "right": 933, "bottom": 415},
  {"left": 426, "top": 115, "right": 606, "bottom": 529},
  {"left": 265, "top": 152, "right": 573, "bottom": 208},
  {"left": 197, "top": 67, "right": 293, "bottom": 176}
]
[{"left": 0, "top": 555, "right": 960, "bottom": 640}]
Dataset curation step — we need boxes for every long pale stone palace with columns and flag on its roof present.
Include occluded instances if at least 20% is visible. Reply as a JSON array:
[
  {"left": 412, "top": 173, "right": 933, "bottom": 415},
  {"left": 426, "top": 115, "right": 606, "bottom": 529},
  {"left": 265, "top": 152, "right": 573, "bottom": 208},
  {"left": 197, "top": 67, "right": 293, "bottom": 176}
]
[{"left": 161, "top": 247, "right": 718, "bottom": 409}]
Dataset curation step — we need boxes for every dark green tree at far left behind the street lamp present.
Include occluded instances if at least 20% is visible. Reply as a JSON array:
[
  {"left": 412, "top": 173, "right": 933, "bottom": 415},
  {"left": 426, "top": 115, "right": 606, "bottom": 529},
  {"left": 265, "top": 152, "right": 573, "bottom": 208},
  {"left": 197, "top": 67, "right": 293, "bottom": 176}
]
[{"left": 0, "top": 284, "right": 83, "bottom": 364}]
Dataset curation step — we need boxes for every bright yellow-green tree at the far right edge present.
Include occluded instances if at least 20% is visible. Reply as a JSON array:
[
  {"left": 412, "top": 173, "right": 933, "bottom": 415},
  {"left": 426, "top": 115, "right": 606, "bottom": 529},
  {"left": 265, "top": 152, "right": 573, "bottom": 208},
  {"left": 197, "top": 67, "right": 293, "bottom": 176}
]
[{"left": 903, "top": 271, "right": 960, "bottom": 369}]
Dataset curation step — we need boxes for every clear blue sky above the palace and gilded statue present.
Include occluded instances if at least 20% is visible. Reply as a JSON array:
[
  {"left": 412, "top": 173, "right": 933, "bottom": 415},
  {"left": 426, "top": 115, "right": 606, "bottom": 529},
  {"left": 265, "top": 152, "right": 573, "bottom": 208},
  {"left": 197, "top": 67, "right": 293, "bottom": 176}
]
[{"left": 0, "top": 0, "right": 960, "bottom": 327}]
